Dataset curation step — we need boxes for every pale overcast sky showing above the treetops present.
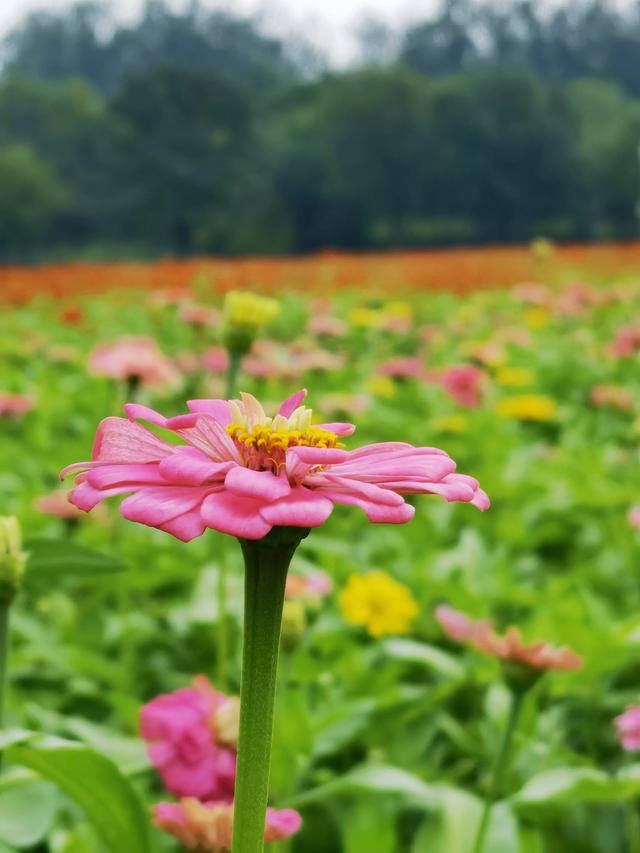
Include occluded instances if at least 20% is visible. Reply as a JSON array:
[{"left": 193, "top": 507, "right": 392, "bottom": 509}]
[{"left": 0, "top": 0, "right": 438, "bottom": 63}]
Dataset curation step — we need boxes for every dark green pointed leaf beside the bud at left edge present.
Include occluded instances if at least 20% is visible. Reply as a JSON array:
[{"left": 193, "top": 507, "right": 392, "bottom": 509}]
[{"left": 24, "top": 538, "right": 126, "bottom": 583}]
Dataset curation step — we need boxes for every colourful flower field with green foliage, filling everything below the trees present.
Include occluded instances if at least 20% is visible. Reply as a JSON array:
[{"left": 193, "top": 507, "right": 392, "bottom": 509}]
[{"left": 0, "top": 243, "right": 640, "bottom": 853}]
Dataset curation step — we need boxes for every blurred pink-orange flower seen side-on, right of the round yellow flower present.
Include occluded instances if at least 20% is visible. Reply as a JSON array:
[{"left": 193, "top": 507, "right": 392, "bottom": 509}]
[{"left": 436, "top": 607, "right": 582, "bottom": 670}]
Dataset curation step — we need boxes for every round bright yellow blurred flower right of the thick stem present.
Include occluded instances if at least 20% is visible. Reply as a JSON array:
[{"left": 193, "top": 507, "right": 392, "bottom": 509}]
[{"left": 340, "top": 571, "right": 418, "bottom": 637}]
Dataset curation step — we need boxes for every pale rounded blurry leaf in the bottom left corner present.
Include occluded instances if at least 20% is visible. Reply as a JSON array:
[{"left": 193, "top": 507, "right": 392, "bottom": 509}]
[{"left": 0, "top": 779, "right": 60, "bottom": 851}]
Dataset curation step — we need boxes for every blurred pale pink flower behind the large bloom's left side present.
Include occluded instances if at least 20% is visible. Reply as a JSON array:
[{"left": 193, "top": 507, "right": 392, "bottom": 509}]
[{"left": 89, "top": 337, "right": 180, "bottom": 386}]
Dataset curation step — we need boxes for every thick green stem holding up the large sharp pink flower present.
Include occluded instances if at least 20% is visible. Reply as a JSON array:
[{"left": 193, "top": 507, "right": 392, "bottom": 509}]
[{"left": 232, "top": 528, "right": 306, "bottom": 853}]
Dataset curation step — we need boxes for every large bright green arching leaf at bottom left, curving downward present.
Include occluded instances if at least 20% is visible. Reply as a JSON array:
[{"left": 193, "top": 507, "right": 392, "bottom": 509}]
[{"left": 7, "top": 738, "right": 150, "bottom": 853}]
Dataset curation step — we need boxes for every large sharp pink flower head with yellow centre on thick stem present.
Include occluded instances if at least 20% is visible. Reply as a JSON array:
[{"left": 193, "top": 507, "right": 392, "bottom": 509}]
[{"left": 61, "top": 391, "right": 489, "bottom": 541}]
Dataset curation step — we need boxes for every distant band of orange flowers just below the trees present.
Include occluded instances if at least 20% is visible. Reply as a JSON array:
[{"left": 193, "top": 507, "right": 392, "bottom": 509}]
[{"left": 0, "top": 242, "right": 640, "bottom": 304}]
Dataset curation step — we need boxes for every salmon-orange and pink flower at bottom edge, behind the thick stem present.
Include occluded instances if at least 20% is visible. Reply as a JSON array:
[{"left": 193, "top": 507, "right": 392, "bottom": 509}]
[{"left": 153, "top": 798, "right": 302, "bottom": 853}]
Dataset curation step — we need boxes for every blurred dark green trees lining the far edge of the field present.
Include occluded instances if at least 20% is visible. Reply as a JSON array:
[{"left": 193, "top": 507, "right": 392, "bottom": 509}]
[{"left": 0, "top": 0, "right": 640, "bottom": 261}]
